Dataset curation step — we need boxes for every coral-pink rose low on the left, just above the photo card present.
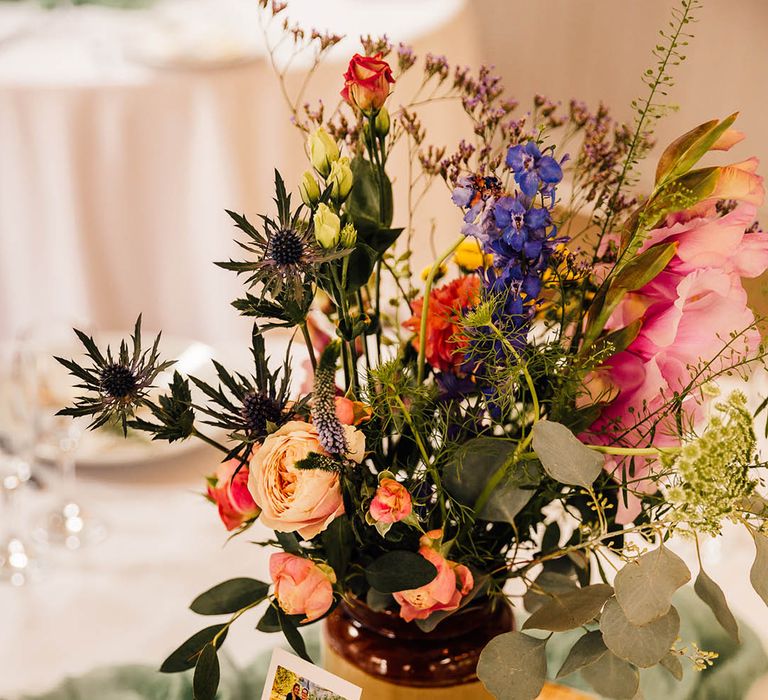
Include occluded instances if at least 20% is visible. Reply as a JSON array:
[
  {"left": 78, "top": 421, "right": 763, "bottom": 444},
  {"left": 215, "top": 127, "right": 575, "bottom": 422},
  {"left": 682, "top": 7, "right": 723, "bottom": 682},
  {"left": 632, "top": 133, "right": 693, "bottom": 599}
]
[{"left": 269, "top": 552, "right": 336, "bottom": 622}]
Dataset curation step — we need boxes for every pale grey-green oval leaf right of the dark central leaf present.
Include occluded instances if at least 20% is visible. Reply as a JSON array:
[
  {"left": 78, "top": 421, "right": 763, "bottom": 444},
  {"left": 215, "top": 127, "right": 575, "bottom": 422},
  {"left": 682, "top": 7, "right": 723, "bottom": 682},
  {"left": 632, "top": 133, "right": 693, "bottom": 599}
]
[{"left": 533, "top": 420, "right": 605, "bottom": 488}]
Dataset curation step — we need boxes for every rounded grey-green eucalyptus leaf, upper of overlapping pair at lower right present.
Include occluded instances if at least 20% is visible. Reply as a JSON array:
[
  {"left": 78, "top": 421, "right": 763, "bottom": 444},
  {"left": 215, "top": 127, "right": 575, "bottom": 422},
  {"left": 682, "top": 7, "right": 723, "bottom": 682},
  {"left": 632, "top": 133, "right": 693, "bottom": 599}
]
[{"left": 613, "top": 546, "right": 691, "bottom": 625}]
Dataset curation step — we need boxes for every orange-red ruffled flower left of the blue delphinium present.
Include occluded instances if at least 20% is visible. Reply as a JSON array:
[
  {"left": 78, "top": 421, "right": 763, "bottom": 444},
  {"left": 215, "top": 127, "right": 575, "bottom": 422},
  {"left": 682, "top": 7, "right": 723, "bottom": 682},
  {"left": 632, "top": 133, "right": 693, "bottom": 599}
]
[{"left": 403, "top": 275, "right": 480, "bottom": 373}]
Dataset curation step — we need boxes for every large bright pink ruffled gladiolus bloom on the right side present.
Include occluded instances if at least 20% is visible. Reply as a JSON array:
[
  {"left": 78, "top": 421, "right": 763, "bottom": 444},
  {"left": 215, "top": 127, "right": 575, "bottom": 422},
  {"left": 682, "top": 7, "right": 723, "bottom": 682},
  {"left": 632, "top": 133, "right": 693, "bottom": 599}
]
[{"left": 586, "top": 172, "right": 768, "bottom": 523}]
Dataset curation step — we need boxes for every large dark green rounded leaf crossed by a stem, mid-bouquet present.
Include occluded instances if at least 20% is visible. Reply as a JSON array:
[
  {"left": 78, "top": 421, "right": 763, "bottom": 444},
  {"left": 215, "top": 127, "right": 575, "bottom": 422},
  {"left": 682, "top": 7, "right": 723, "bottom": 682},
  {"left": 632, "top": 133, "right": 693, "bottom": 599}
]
[{"left": 443, "top": 437, "right": 541, "bottom": 523}]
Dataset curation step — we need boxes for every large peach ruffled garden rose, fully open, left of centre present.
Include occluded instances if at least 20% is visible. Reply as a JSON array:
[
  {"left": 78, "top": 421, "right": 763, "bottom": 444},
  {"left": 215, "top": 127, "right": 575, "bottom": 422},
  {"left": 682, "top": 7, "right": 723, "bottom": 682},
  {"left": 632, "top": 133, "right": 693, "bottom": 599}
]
[{"left": 248, "top": 421, "right": 365, "bottom": 540}]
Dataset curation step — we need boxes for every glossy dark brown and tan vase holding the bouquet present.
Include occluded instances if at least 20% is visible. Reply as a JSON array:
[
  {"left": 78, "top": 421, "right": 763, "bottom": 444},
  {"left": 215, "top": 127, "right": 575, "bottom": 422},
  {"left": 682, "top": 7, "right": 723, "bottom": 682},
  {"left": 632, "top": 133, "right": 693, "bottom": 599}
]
[{"left": 324, "top": 600, "right": 584, "bottom": 700}]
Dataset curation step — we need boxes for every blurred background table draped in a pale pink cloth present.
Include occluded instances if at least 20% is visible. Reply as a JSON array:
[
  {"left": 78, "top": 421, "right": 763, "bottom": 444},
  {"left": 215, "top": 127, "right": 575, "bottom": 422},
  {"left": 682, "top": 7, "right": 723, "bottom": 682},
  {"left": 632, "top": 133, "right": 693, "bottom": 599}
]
[{"left": 0, "top": 0, "right": 476, "bottom": 342}]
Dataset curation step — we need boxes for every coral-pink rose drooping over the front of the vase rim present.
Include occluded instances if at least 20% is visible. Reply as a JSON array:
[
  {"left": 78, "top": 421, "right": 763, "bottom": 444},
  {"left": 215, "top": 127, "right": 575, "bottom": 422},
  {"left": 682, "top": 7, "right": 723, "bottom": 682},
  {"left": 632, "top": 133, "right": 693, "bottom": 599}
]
[{"left": 394, "top": 530, "right": 475, "bottom": 622}]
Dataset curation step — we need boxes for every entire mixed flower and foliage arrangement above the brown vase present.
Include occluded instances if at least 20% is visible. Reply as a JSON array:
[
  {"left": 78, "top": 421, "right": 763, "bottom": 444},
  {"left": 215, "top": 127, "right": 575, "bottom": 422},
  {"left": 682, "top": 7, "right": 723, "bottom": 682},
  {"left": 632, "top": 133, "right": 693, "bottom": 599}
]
[{"left": 60, "top": 0, "right": 768, "bottom": 699}]
